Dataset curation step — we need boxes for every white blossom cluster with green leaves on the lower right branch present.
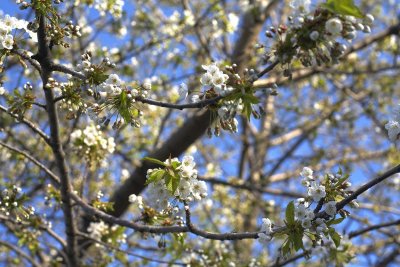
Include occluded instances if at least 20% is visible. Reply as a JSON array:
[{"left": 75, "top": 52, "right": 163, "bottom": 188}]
[{"left": 258, "top": 167, "right": 358, "bottom": 262}]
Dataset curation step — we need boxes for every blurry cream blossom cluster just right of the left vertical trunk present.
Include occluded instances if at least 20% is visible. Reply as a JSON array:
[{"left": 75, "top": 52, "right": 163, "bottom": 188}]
[{"left": 71, "top": 124, "right": 115, "bottom": 169}]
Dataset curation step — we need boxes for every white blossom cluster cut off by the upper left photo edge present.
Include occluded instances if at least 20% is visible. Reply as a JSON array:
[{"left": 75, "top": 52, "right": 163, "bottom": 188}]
[{"left": 0, "top": 15, "right": 36, "bottom": 50}]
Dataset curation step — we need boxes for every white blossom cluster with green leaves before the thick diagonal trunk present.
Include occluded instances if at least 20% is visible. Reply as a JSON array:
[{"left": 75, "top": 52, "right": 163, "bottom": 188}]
[{"left": 146, "top": 156, "right": 207, "bottom": 213}]
